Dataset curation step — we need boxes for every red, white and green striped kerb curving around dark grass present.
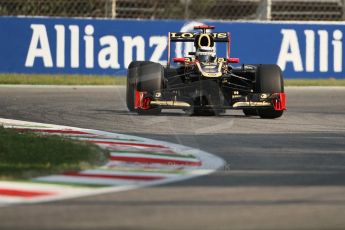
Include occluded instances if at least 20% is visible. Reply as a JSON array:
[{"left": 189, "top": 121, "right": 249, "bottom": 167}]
[{"left": 0, "top": 118, "right": 225, "bottom": 207}]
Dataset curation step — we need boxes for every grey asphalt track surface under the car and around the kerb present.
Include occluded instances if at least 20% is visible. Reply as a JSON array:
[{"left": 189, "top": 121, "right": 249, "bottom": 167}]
[{"left": 0, "top": 87, "right": 345, "bottom": 230}]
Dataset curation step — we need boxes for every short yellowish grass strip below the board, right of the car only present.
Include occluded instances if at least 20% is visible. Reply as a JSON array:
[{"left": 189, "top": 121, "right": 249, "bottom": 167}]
[{"left": 284, "top": 78, "right": 345, "bottom": 86}]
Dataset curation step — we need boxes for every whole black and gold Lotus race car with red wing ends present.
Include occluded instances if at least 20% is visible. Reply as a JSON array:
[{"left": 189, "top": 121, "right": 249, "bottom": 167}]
[{"left": 126, "top": 25, "right": 286, "bottom": 118}]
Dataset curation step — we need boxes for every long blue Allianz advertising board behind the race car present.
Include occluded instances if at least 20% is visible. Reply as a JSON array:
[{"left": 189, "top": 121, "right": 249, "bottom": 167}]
[{"left": 0, "top": 17, "right": 345, "bottom": 78}]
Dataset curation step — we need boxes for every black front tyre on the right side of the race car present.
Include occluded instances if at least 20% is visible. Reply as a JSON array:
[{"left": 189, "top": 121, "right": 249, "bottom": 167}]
[{"left": 255, "top": 65, "right": 284, "bottom": 119}]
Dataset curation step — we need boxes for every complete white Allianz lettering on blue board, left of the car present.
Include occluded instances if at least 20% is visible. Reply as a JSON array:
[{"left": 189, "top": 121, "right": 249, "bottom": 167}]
[{"left": 25, "top": 24, "right": 167, "bottom": 69}]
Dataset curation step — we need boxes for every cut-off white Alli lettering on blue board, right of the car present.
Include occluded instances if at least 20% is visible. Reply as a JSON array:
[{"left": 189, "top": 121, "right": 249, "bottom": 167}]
[{"left": 277, "top": 29, "right": 343, "bottom": 72}]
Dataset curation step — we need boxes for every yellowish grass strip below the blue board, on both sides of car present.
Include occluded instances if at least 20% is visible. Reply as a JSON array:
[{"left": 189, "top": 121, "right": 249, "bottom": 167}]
[{"left": 0, "top": 74, "right": 345, "bottom": 86}]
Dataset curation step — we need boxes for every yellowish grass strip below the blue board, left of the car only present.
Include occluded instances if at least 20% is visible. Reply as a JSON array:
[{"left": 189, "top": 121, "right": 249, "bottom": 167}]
[{"left": 0, "top": 74, "right": 126, "bottom": 85}]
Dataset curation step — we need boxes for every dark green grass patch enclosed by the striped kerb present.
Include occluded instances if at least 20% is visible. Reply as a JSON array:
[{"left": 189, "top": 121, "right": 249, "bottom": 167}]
[{"left": 0, "top": 127, "right": 108, "bottom": 179}]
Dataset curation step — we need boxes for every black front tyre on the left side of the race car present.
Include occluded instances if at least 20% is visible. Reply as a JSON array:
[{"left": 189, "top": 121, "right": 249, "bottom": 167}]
[{"left": 137, "top": 62, "right": 164, "bottom": 115}]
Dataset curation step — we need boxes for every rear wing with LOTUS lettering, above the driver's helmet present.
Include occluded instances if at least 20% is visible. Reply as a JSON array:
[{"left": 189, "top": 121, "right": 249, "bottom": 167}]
[{"left": 167, "top": 30, "right": 230, "bottom": 67}]
